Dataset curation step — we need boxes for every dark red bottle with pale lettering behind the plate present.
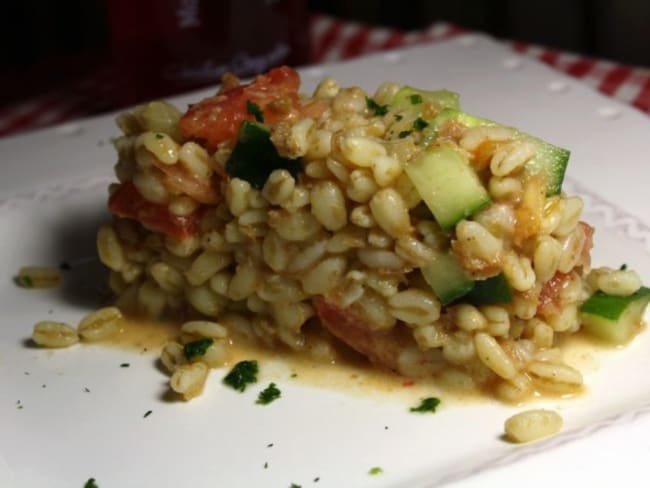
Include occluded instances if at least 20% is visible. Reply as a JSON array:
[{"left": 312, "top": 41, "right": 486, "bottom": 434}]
[{"left": 106, "top": 0, "right": 310, "bottom": 105}]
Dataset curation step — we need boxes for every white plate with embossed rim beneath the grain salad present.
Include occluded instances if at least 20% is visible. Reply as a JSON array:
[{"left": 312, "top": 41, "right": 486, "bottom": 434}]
[{"left": 0, "top": 35, "right": 650, "bottom": 488}]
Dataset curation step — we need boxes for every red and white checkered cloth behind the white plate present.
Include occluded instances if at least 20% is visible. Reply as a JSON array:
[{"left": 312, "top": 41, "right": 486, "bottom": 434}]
[{"left": 0, "top": 14, "right": 650, "bottom": 136}]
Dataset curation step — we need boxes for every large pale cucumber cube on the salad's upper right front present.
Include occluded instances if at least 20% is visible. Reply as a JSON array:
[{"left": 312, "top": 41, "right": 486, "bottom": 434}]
[{"left": 405, "top": 146, "right": 490, "bottom": 230}]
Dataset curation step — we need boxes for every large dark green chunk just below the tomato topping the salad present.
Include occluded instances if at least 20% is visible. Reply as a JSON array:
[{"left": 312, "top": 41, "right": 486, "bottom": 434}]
[{"left": 226, "top": 120, "right": 302, "bottom": 190}]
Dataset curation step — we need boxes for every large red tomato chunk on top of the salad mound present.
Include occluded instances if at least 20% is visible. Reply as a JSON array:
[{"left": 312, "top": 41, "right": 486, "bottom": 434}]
[{"left": 179, "top": 66, "right": 300, "bottom": 151}]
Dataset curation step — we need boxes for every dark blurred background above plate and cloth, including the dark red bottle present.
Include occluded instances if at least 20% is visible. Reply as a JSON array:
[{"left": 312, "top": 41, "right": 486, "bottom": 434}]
[{"left": 0, "top": 0, "right": 650, "bottom": 134}]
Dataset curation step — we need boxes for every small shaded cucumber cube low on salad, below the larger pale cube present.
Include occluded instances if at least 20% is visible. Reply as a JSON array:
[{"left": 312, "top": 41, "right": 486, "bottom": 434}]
[{"left": 420, "top": 252, "right": 474, "bottom": 305}]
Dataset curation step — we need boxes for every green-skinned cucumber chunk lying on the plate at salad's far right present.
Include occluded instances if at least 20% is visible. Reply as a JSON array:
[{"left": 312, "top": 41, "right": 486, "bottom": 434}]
[{"left": 580, "top": 287, "right": 650, "bottom": 344}]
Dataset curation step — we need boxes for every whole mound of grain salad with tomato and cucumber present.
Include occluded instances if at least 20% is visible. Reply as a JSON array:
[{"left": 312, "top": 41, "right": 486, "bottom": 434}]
[{"left": 38, "top": 67, "right": 650, "bottom": 402}]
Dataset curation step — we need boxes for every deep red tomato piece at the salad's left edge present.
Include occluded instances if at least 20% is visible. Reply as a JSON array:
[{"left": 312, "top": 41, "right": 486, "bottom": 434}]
[{"left": 108, "top": 182, "right": 199, "bottom": 239}]
